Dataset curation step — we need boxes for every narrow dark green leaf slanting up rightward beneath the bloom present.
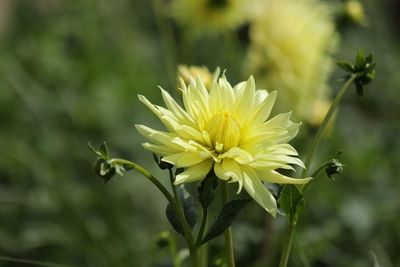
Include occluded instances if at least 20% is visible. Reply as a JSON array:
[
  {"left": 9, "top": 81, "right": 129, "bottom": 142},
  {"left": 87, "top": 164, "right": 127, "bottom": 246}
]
[{"left": 201, "top": 198, "right": 251, "bottom": 244}]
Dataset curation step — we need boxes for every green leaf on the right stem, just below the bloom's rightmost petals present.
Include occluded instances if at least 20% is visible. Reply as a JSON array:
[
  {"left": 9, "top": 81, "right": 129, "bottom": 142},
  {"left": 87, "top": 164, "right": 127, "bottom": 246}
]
[{"left": 278, "top": 184, "right": 305, "bottom": 224}]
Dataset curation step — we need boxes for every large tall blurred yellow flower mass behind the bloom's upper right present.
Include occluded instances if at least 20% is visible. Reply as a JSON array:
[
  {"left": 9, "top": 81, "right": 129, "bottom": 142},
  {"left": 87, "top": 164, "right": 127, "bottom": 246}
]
[{"left": 247, "top": 0, "right": 338, "bottom": 124}]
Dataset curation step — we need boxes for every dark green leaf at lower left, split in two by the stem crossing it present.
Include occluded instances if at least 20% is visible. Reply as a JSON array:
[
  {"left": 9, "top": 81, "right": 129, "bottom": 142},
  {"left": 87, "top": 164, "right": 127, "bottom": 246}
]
[{"left": 165, "top": 190, "right": 198, "bottom": 235}]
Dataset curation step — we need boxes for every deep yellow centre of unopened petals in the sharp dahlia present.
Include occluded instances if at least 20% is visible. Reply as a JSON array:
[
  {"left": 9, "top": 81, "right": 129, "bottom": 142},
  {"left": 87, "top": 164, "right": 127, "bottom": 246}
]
[{"left": 207, "top": 112, "right": 240, "bottom": 153}]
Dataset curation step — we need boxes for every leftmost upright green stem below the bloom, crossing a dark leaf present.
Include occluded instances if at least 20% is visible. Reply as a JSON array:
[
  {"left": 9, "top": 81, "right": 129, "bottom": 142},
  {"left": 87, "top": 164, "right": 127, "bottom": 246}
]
[{"left": 169, "top": 169, "right": 198, "bottom": 267}]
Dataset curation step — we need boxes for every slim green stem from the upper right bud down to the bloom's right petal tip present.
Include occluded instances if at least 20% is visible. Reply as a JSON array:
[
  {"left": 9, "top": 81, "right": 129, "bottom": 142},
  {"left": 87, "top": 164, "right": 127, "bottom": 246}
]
[{"left": 301, "top": 74, "right": 357, "bottom": 178}]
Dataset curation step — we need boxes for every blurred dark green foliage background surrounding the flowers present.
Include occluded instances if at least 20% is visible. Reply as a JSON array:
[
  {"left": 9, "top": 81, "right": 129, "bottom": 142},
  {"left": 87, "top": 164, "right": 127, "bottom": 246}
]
[{"left": 0, "top": 0, "right": 400, "bottom": 267}]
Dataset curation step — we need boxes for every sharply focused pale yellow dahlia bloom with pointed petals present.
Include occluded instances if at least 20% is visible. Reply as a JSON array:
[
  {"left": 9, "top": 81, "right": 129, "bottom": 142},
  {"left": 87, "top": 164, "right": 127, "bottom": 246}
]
[{"left": 136, "top": 77, "right": 311, "bottom": 216}]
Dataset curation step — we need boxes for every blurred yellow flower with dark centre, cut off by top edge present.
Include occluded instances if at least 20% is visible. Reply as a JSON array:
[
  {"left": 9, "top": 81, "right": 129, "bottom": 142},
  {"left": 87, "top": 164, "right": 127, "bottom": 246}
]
[{"left": 172, "top": 0, "right": 246, "bottom": 34}]
